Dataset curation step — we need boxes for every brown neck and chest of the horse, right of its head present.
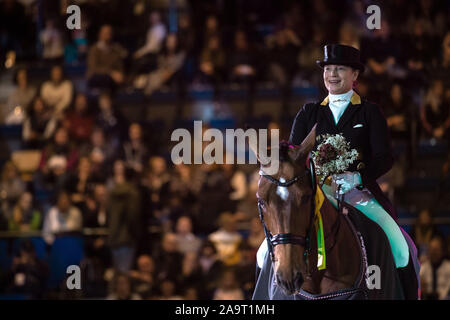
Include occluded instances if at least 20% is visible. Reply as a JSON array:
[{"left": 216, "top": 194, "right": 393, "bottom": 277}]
[{"left": 303, "top": 198, "right": 360, "bottom": 294}]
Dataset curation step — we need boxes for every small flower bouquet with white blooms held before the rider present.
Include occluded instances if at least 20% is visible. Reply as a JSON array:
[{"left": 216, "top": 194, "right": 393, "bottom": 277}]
[{"left": 312, "top": 134, "right": 358, "bottom": 184}]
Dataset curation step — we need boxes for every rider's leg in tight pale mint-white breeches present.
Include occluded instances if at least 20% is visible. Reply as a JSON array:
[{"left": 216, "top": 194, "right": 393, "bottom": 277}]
[{"left": 322, "top": 184, "right": 409, "bottom": 268}]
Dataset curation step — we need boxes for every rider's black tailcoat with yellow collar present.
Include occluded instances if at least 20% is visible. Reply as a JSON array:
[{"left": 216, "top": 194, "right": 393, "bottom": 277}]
[{"left": 289, "top": 92, "right": 397, "bottom": 220}]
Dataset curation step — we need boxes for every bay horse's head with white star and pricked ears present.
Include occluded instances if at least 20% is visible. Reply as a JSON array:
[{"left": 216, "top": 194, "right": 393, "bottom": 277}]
[{"left": 251, "top": 127, "right": 317, "bottom": 294}]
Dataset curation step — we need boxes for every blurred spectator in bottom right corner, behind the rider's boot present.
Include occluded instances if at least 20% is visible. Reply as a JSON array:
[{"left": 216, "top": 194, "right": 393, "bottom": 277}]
[{"left": 420, "top": 236, "right": 450, "bottom": 300}]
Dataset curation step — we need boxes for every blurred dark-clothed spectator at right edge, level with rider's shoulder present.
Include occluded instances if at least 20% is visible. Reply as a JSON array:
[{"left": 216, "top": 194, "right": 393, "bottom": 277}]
[{"left": 420, "top": 80, "right": 450, "bottom": 140}]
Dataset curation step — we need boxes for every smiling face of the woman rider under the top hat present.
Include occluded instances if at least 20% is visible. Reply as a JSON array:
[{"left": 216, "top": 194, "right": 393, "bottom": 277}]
[{"left": 323, "top": 64, "right": 359, "bottom": 94}]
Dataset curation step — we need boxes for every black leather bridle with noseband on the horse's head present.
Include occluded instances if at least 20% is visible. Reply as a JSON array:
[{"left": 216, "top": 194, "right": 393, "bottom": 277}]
[{"left": 258, "top": 157, "right": 317, "bottom": 272}]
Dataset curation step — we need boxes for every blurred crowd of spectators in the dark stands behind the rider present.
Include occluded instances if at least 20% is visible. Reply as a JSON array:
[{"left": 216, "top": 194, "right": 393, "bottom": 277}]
[{"left": 0, "top": 0, "right": 450, "bottom": 299}]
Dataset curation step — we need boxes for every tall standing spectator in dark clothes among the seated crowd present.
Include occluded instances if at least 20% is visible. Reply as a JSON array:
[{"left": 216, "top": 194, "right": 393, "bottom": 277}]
[{"left": 106, "top": 161, "right": 141, "bottom": 272}]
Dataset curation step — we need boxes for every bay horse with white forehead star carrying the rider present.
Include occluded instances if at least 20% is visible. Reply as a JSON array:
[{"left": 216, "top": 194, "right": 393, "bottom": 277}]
[{"left": 250, "top": 127, "right": 417, "bottom": 300}]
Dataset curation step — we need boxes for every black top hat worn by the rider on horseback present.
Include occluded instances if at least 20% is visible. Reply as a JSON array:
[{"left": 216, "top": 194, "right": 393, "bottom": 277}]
[{"left": 316, "top": 44, "right": 365, "bottom": 72}]
